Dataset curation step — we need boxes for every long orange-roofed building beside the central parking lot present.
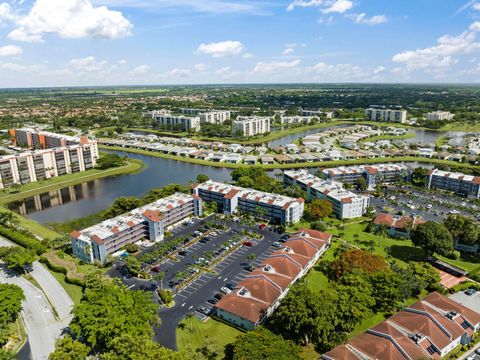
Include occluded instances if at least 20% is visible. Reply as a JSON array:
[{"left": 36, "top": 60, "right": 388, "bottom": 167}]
[{"left": 215, "top": 230, "right": 332, "bottom": 330}]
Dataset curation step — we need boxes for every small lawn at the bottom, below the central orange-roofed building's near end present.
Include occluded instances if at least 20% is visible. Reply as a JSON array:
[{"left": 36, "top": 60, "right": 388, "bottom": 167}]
[{"left": 177, "top": 317, "right": 242, "bottom": 359}]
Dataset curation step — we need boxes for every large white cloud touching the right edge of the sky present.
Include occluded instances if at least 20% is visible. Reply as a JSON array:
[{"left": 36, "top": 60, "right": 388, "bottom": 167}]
[{"left": 392, "top": 22, "right": 480, "bottom": 70}]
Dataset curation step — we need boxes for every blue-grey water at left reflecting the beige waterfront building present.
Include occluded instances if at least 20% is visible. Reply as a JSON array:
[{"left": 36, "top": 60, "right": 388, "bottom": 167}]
[{"left": 8, "top": 152, "right": 231, "bottom": 224}]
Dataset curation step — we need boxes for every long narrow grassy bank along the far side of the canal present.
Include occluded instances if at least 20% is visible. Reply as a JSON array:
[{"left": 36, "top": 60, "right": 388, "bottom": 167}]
[{"left": 100, "top": 145, "right": 480, "bottom": 171}]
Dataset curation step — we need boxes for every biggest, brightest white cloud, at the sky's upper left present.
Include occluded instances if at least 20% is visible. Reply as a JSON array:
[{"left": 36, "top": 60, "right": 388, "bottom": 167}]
[{"left": 8, "top": 0, "right": 132, "bottom": 42}]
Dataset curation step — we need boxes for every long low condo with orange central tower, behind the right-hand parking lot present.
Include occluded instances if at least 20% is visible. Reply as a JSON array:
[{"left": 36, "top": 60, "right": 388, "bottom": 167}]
[{"left": 322, "top": 164, "right": 412, "bottom": 190}]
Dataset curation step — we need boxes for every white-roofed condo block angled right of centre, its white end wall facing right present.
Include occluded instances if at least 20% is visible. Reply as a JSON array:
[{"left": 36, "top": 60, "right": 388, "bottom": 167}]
[{"left": 283, "top": 170, "right": 370, "bottom": 219}]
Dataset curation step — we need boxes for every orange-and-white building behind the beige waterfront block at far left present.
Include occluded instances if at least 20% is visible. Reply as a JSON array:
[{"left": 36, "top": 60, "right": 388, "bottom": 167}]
[{"left": 9, "top": 128, "right": 90, "bottom": 150}]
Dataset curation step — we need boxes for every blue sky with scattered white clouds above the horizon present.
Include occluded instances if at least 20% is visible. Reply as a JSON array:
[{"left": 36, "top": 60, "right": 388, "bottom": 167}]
[{"left": 0, "top": 0, "right": 480, "bottom": 88}]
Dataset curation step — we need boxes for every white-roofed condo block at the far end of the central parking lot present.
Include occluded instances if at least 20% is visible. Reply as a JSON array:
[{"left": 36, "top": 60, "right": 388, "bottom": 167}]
[{"left": 193, "top": 180, "right": 304, "bottom": 225}]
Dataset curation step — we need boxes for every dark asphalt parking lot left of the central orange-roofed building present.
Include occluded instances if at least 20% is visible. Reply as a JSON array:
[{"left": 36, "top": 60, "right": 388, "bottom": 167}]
[{"left": 109, "top": 215, "right": 281, "bottom": 349}]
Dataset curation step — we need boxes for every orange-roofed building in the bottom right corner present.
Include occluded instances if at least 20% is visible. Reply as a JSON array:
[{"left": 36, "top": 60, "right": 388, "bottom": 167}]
[{"left": 322, "top": 292, "right": 480, "bottom": 360}]
